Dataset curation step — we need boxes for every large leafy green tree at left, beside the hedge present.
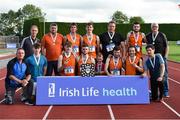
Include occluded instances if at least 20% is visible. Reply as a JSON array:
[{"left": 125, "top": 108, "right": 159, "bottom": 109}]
[{"left": 0, "top": 4, "right": 45, "bottom": 35}]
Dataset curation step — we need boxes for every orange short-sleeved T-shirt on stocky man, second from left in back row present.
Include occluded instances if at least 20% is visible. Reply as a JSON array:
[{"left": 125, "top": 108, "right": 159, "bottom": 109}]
[{"left": 41, "top": 33, "right": 63, "bottom": 61}]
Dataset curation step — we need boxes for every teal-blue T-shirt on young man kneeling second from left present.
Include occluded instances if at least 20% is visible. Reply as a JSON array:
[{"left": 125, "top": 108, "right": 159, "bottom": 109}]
[{"left": 26, "top": 55, "right": 47, "bottom": 82}]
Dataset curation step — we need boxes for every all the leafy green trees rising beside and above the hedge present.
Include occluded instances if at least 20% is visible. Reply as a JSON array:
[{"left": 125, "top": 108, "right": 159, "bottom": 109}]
[{"left": 0, "top": 4, "right": 145, "bottom": 36}]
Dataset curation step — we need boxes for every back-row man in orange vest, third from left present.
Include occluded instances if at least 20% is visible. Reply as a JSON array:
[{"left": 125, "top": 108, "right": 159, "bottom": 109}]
[{"left": 64, "top": 23, "right": 82, "bottom": 56}]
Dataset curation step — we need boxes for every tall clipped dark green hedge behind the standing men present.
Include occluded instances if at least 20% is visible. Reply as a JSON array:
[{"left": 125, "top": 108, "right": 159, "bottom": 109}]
[{"left": 23, "top": 19, "right": 180, "bottom": 41}]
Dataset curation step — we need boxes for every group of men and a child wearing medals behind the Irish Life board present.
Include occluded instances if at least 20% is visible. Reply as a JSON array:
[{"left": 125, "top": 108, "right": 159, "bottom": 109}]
[{"left": 5, "top": 21, "right": 169, "bottom": 104}]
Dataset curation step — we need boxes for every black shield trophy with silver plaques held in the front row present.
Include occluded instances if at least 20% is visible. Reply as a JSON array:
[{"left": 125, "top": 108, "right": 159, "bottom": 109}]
[{"left": 80, "top": 64, "right": 95, "bottom": 77}]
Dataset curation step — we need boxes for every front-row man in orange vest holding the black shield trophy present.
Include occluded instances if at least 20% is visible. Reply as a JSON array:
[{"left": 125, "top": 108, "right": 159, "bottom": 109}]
[{"left": 77, "top": 44, "right": 95, "bottom": 75}]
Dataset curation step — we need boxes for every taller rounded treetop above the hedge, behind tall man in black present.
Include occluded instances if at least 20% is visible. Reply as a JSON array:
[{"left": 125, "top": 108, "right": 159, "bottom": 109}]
[{"left": 112, "top": 11, "right": 129, "bottom": 24}]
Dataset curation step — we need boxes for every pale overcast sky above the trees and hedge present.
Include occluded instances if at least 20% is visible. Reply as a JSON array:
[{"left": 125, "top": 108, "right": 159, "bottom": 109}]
[{"left": 0, "top": 0, "right": 180, "bottom": 23}]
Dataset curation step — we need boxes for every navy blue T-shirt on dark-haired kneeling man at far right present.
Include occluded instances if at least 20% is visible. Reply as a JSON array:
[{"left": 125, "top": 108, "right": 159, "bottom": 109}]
[{"left": 144, "top": 54, "right": 164, "bottom": 80}]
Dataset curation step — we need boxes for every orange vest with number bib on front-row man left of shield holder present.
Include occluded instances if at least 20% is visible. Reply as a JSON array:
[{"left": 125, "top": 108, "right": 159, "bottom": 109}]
[{"left": 61, "top": 54, "right": 76, "bottom": 76}]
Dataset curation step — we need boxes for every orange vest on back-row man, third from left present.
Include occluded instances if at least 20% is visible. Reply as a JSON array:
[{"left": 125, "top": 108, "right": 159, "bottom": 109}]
[{"left": 66, "top": 34, "right": 81, "bottom": 56}]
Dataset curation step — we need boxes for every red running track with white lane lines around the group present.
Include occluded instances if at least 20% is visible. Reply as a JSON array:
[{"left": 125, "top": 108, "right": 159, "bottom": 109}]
[{"left": 0, "top": 59, "right": 180, "bottom": 119}]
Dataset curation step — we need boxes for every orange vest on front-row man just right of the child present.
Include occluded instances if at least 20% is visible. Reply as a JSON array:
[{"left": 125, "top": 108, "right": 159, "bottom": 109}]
[{"left": 109, "top": 57, "right": 122, "bottom": 75}]
